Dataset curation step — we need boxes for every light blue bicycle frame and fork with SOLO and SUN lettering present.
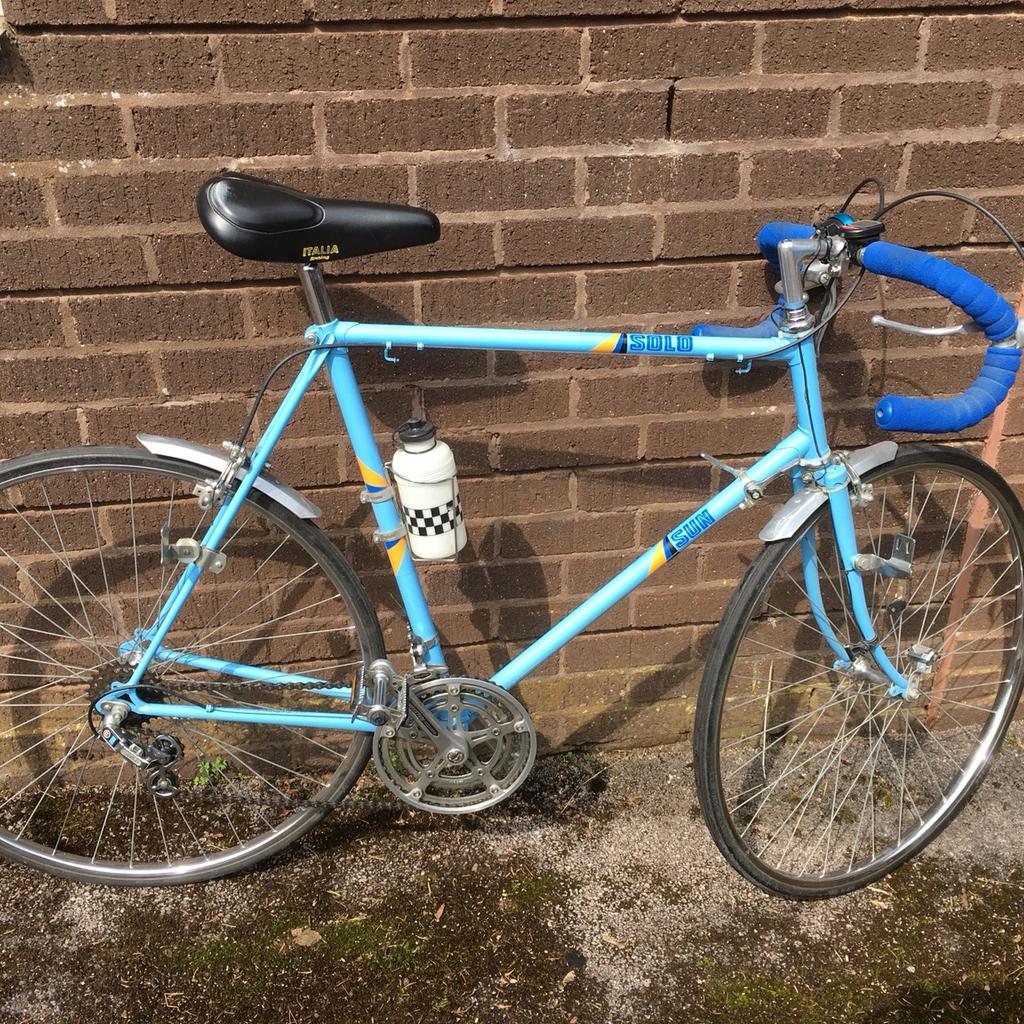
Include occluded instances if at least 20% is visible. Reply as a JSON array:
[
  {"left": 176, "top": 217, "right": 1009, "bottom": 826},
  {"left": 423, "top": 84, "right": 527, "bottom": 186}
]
[{"left": 112, "top": 321, "right": 907, "bottom": 732}]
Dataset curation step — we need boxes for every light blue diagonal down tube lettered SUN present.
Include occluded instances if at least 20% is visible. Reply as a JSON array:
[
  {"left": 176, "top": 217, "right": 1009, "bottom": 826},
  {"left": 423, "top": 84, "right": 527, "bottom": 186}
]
[{"left": 492, "top": 430, "right": 812, "bottom": 689}]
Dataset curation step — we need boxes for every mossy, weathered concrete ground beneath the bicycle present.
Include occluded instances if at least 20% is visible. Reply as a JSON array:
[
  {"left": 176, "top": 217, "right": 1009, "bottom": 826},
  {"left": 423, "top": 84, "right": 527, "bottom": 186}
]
[{"left": 0, "top": 741, "right": 1024, "bottom": 1024}]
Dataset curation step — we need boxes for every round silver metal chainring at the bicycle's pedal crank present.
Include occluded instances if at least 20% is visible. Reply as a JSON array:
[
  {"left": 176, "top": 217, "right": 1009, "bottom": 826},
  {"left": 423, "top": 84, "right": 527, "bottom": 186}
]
[{"left": 374, "top": 678, "right": 537, "bottom": 814}]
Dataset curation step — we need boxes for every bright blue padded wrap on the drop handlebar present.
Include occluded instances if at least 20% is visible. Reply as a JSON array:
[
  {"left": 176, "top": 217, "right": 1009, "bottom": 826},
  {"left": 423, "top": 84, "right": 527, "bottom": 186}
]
[{"left": 758, "top": 221, "right": 1021, "bottom": 433}]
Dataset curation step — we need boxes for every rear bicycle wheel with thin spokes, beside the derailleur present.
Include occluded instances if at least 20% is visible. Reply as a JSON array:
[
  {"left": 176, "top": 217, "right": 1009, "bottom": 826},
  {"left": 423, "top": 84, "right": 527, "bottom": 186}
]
[{"left": 0, "top": 447, "right": 384, "bottom": 885}]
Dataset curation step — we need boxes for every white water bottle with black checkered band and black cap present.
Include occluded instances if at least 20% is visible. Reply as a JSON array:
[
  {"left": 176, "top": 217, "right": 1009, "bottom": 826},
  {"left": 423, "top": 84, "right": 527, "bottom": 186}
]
[{"left": 391, "top": 420, "right": 468, "bottom": 560}]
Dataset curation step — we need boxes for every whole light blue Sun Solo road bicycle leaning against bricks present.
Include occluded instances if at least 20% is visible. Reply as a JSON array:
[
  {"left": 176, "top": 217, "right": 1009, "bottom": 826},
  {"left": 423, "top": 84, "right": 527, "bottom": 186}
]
[{"left": 0, "top": 172, "right": 1024, "bottom": 898}]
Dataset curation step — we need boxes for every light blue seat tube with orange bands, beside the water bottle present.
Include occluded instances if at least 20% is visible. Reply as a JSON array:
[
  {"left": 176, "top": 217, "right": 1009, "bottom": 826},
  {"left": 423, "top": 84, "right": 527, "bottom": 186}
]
[{"left": 328, "top": 348, "right": 447, "bottom": 671}]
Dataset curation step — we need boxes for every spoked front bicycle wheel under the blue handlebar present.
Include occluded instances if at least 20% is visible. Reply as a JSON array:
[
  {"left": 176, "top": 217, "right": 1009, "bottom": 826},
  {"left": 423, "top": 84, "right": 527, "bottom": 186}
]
[{"left": 694, "top": 444, "right": 1024, "bottom": 899}]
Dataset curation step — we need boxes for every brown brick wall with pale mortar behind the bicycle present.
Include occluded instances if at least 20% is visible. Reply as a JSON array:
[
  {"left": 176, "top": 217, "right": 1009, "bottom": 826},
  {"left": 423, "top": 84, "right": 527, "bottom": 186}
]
[{"left": 0, "top": 0, "right": 1024, "bottom": 745}]
